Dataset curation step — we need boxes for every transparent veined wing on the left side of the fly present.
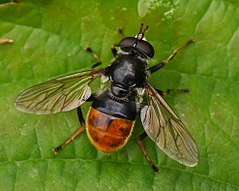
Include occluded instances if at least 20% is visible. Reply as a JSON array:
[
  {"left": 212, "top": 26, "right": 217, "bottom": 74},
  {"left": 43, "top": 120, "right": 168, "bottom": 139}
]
[{"left": 15, "top": 69, "right": 104, "bottom": 114}]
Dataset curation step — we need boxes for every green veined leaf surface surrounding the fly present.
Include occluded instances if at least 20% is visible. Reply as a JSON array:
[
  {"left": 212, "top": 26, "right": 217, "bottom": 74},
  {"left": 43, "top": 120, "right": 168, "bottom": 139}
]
[{"left": 0, "top": 0, "right": 239, "bottom": 191}]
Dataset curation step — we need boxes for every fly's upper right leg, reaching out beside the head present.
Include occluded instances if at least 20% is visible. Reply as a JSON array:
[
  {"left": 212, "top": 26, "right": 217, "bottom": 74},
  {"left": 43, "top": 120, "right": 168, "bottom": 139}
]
[{"left": 149, "top": 38, "right": 194, "bottom": 73}]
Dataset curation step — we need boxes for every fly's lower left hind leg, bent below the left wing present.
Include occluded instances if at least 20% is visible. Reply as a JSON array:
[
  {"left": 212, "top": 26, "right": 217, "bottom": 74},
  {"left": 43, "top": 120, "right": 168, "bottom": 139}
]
[{"left": 52, "top": 107, "right": 85, "bottom": 154}]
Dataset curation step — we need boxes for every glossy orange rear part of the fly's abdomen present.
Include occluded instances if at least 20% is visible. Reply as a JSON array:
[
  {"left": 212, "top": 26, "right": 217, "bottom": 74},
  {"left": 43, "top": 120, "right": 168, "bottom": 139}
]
[{"left": 86, "top": 108, "right": 134, "bottom": 153}]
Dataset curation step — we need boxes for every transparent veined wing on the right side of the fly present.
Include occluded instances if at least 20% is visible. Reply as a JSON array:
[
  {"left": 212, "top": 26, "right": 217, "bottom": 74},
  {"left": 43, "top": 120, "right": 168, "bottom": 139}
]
[{"left": 140, "top": 84, "right": 198, "bottom": 167}]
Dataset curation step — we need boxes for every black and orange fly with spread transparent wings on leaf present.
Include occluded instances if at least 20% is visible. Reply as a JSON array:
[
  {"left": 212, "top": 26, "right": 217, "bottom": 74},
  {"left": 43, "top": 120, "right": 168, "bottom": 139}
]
[{"left": 15, "top": 24, "right": 198, "bottom": 173}]
